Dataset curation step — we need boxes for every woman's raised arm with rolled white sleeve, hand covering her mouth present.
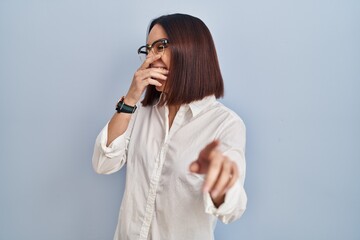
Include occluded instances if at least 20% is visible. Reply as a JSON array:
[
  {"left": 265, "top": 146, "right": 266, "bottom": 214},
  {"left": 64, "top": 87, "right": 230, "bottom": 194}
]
[{"left": 92, "top": 55, "right": 168, "bottom": 174}]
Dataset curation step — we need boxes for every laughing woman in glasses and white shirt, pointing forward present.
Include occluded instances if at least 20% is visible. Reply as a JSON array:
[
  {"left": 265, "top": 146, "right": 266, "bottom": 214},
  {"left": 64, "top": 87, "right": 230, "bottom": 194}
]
[{"left": 93, "top": 14, "right": 247, "bottom": 240}]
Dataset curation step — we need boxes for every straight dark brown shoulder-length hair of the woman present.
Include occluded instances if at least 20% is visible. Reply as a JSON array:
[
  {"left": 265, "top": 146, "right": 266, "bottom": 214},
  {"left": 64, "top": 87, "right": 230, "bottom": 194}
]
[{"left": 142, "top": 14, "right": 224, "bottom": 106}]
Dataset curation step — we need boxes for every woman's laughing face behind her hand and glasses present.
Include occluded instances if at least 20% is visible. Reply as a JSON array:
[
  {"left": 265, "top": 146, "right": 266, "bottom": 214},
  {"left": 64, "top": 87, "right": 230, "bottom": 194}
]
[{"left": 147, "top": 24, "right": 170, "bottom": 92}]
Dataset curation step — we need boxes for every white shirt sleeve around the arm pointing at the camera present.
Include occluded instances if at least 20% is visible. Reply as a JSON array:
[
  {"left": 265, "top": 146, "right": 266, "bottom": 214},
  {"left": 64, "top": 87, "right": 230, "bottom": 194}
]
[{"left": 204, "top": 113, "right": 247, "bottom": 224}]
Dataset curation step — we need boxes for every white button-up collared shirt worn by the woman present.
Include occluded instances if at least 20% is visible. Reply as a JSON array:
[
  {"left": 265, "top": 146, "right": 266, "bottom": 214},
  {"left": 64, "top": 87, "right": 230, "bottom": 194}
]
[{"left": 92, "top": 96, "right": 247, "bottom": 240}]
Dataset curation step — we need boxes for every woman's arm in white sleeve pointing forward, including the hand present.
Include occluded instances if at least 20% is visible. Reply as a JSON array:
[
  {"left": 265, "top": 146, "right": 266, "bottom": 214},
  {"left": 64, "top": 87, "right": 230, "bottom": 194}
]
[{"left": 190, "top": 119, "right": 247, "bottom": 223}]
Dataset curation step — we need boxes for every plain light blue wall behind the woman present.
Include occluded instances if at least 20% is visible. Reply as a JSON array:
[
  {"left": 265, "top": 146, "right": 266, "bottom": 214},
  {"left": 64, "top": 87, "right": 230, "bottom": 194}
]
[{"left": 0, "top": 0, "right": 360, "bottom": 240}]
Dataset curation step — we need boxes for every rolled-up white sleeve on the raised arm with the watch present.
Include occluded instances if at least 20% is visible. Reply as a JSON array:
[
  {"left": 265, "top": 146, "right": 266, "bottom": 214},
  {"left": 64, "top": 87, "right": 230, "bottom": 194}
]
[{"left": 92, "top": 111, "right": 136, "bottom": 174}]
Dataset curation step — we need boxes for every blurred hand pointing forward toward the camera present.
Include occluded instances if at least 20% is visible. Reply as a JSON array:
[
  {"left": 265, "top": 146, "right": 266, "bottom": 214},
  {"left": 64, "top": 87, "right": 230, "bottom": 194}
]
[{"left": 189, "top": 140, "right": 239, "bottom": 207}]
